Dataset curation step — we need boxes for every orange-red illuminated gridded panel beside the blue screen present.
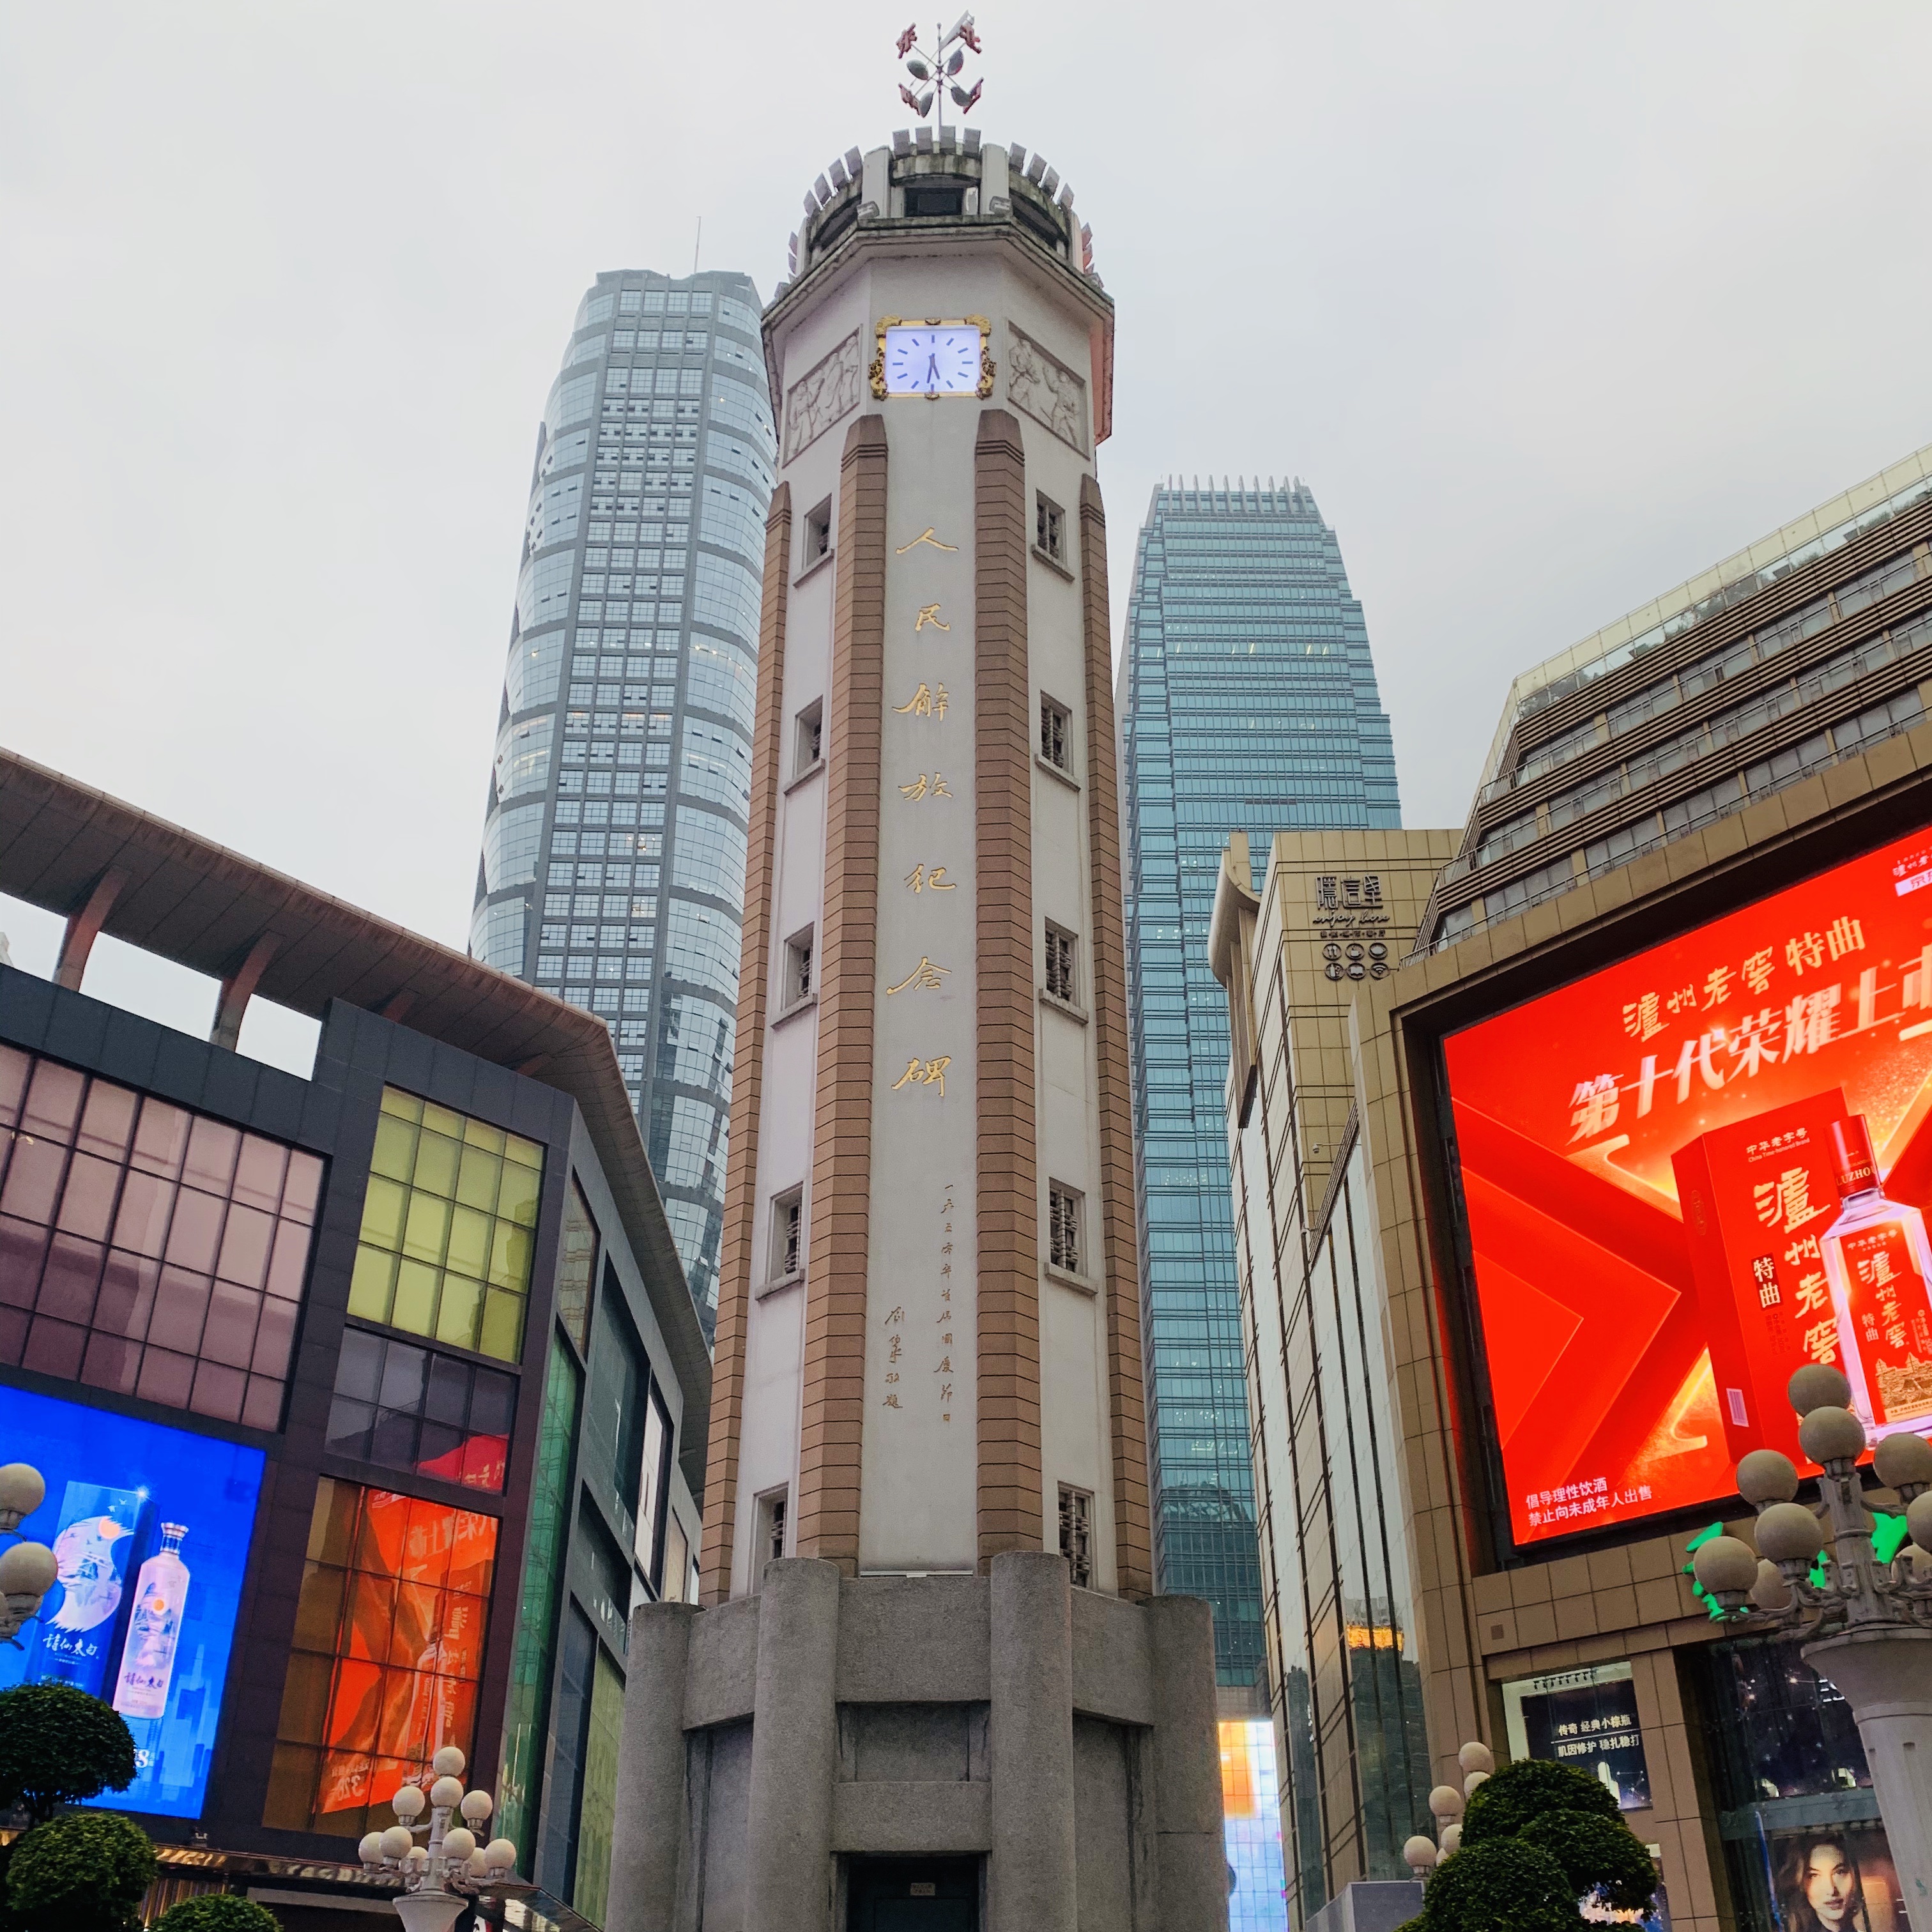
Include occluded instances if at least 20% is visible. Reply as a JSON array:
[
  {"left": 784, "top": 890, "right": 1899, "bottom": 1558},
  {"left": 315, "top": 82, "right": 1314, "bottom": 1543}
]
[{"left": 263, "top": 1478, "right": 496, "bottom": 1837}]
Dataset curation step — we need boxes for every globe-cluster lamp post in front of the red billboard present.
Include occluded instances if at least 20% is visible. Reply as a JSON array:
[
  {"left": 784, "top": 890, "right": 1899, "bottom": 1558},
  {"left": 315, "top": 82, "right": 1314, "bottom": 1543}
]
[{"left": 1692, "top": 1364, "right": 1932, "bottom": 1922}]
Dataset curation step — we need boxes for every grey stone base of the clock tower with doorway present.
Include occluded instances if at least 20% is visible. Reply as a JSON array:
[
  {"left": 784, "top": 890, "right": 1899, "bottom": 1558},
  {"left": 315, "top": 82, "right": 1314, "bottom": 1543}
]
[{"left": 605, "top": 1551, "right": 1227, "bottom": 1932}]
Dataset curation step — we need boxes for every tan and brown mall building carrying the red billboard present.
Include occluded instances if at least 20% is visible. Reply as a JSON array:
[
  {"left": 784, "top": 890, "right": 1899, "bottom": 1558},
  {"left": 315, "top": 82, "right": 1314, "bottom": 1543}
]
[{"left": 1211, "top": 450, "right": 1932, "bottom": 1932}]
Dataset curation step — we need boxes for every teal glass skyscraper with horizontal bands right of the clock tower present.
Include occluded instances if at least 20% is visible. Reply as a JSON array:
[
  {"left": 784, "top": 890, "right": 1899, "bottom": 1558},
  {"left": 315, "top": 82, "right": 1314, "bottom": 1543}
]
[{"left": 1119, "top": 481, "right": 1400, "bottom": 1710}]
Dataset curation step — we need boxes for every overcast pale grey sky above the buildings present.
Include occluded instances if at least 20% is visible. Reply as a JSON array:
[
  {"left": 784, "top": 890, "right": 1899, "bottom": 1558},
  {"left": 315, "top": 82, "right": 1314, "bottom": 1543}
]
[{"left": 0, "top": 0, "right": 1932, "bottom": 1059}]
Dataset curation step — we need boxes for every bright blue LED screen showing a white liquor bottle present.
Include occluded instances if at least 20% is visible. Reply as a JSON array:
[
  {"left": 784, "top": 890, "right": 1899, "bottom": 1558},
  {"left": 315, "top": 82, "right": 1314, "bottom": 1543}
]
[{"left": 0, "top": 1389, "right": 263, "bottom": 1818}]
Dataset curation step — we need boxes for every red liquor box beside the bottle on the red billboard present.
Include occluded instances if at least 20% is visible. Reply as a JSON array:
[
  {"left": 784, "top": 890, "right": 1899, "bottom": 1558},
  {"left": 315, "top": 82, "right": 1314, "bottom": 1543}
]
[{"left": 1671, "top": 1088, "right": 1845, "bottom": 1468}]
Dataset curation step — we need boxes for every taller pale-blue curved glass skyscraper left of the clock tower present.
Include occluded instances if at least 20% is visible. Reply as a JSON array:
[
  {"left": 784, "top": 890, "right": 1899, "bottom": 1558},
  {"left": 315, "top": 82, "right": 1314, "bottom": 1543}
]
[{"left": 470, "top": 270, "right": 777, "bottom": 1335}]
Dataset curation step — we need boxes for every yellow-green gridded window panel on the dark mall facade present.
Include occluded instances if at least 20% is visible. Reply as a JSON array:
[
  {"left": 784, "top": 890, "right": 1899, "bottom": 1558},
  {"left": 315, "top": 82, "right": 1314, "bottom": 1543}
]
[{"left": 349, "top": 1088, "right": 543, "bottom": 1362}]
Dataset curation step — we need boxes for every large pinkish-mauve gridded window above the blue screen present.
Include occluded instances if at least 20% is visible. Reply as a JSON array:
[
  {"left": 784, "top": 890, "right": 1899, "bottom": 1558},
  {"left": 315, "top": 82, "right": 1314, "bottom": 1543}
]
[{"left": 0, "top": 1047, "right": 323, "bottom": 1430}]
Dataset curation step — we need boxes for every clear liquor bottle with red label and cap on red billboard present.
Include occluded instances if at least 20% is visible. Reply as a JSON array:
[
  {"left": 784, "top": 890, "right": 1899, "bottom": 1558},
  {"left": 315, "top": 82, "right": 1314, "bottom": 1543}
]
[{"left": 1818, "top": 1113, "right": 1932, "bottom": 1438}]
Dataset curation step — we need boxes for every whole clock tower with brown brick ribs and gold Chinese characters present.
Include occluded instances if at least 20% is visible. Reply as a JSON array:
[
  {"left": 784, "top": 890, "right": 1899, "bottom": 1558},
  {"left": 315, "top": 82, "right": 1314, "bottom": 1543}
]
[{"left": 611, "top": 128, "right": 1227, "bottom": 1932}]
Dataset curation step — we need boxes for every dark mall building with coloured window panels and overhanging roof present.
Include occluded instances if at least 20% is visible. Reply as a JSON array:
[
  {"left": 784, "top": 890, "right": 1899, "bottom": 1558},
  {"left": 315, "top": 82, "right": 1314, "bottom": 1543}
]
[{"left": 0, "top": 751, "right": 711, "bottom": 1932}]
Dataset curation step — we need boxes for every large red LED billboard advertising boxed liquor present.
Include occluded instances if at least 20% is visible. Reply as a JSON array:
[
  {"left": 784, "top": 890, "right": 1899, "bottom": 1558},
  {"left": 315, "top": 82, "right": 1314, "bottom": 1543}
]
[{"left": 1443, "top": 832, "right": 1932, "bottom": 1544}]
